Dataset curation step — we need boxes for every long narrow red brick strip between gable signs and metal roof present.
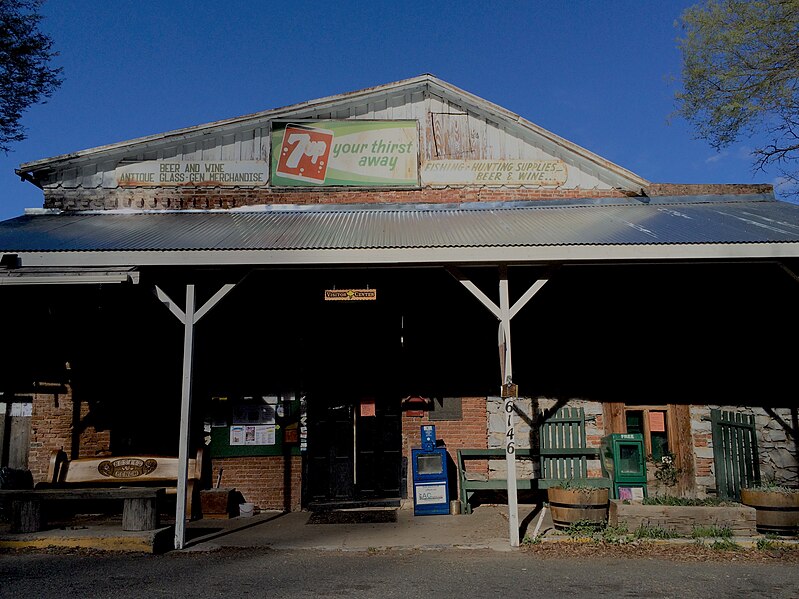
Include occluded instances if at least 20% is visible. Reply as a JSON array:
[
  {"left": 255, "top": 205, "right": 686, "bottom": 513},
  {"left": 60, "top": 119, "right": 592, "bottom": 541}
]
[{"left": 44, "top": 187, "right": 628, "bottom": 210}]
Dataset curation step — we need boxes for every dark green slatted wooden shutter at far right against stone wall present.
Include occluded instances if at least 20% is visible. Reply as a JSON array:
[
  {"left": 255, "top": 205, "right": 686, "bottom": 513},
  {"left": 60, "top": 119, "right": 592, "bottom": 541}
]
[{"left": 710, "top": 409, "right": 760, "bottom": 501}]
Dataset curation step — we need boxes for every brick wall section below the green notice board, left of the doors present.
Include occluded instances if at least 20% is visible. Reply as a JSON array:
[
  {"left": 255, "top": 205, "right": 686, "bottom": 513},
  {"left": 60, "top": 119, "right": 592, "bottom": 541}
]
[{"left": 211, "top": 456, "right": 302, "bottom": 511}]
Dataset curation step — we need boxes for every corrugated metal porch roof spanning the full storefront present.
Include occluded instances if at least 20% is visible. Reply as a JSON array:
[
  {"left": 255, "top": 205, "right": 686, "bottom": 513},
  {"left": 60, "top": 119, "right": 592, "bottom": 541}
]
[{"left": 0, "top": 195, "right": 799, "bottom": 264}]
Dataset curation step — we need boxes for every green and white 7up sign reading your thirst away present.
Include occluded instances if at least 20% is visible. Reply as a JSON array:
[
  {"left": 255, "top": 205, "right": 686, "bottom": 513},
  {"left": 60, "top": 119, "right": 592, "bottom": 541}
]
[{"left": 270, "top": 120, "right": 419, "bottom": 187}]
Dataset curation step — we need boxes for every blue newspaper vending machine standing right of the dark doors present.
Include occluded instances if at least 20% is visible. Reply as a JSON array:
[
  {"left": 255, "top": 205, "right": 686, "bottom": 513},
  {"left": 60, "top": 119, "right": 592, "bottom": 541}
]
[{"left": 411, "top": 424, "right": 449, "bottom": 516}]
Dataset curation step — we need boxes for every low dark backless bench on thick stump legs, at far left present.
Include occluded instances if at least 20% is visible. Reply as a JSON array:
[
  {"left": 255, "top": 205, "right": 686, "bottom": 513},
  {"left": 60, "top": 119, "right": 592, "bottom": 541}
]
[{"left": 0, "top": 487, "right": 165, "bottom": 533}]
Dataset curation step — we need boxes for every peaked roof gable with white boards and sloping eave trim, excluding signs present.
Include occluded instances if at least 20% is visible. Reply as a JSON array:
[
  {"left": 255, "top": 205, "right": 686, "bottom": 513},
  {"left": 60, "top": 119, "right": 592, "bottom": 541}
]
[{"left": 17, "top": 74, "right": 649, "bottom": 193}]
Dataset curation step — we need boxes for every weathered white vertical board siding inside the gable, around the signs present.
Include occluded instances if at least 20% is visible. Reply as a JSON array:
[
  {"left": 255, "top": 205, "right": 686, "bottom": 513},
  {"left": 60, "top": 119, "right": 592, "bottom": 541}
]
[{"left": 45, "top": 90, "right": 611, "bottom": 190}]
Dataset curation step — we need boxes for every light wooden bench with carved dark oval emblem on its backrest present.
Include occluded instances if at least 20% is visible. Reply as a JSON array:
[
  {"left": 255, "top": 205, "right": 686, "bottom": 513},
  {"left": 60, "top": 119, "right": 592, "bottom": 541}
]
[{"left": 35, "top": 448, "right": 203, "bottom": 518}]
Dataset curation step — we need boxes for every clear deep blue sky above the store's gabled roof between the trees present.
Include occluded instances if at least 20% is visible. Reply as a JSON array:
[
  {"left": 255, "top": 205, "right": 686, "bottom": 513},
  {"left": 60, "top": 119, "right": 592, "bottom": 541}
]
[{"left": 0, "top": 0, "right": 792, "bottom": 219}]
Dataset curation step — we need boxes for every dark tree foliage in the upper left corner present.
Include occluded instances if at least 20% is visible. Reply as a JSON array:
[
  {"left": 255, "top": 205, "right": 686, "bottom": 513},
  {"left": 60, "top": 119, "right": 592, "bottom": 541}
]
[{"left": 0, "top": 0, "right": 62, "bottom": 154}]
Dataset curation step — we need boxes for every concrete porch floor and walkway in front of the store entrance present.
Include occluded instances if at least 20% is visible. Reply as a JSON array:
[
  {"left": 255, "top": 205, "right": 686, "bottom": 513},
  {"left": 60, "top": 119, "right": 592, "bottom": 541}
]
[{"left": 0, "top": 505, "right": 552, "bottom": 553}]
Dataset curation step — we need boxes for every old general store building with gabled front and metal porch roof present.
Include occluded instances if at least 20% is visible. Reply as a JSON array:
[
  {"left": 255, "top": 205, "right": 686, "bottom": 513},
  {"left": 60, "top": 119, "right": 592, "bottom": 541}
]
[{"left": 0, "top": 75, "right": 799, "bottom": 540}]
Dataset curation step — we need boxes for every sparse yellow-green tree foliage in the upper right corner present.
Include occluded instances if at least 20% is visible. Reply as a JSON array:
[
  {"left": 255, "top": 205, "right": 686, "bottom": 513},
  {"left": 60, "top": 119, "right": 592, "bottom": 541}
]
[{"left": 676, "top": 0, "right": 799, "bottom": 193}]
